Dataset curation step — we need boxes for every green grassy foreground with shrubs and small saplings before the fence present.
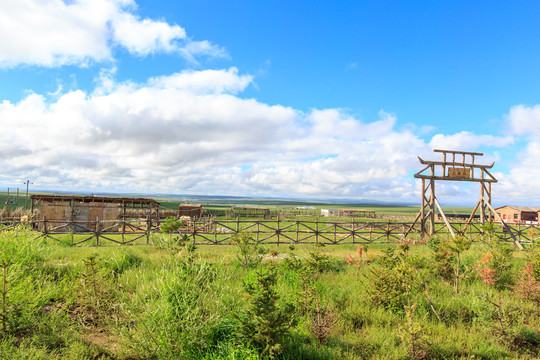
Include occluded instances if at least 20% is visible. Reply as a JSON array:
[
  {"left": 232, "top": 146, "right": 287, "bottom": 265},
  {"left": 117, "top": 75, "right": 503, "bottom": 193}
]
[{"left": 0, "top": 227, "right": 540, "bottom": 360}]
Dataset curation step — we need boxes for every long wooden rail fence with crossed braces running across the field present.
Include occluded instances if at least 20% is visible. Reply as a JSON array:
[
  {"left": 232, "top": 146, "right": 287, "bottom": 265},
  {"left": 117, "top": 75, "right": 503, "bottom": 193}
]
[{"left": 0, "top": 218, "right": 540, "bottom": 246}]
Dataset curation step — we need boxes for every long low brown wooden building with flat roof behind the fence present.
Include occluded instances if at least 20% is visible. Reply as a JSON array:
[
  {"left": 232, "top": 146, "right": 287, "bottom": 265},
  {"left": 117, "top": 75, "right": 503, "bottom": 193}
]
[{"left": 30, "top": 195, "right": 160, "bottom": 232}]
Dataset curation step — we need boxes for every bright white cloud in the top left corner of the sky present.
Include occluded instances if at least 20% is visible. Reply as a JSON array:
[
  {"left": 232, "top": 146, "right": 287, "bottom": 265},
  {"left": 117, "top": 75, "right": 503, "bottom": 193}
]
[{"left": 0, "top": 0, "right": 225, "bottom": 67}]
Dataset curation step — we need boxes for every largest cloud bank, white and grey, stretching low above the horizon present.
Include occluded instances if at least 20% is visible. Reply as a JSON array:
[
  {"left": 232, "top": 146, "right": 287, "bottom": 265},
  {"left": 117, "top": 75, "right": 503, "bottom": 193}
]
[{"left": 0, "top": 68, "right": 436, "bottom": 199}]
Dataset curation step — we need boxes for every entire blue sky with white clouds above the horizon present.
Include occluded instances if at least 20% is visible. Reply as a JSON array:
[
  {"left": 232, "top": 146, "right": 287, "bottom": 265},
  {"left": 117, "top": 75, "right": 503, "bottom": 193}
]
[{"left": 0, "top": 0, "right": 540, "bottom": 206}]
